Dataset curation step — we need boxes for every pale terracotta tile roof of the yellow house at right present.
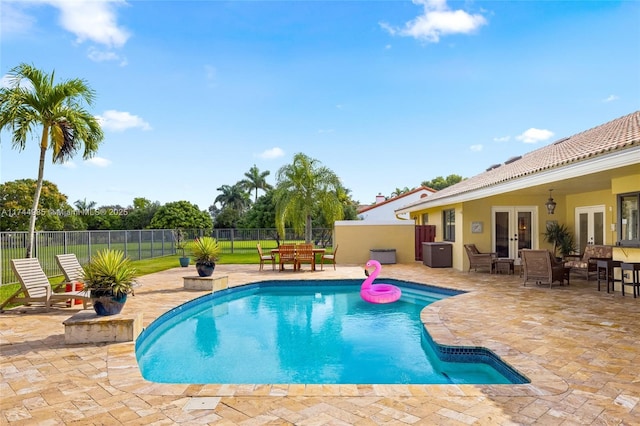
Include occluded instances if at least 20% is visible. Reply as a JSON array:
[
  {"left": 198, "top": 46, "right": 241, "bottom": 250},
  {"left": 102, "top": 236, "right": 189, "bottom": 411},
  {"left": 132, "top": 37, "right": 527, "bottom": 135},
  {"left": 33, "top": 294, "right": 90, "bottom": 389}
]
[{"left": 396, "top": 111, "right": 640, "bottom": 214}]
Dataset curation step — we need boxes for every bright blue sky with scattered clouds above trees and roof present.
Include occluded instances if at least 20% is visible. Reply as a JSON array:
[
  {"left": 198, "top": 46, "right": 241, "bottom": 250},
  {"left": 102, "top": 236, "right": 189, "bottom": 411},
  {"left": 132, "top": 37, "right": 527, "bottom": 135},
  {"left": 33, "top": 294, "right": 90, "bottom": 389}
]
[{"left": 0, "top": 0, "right": 640, "bottom": 210}]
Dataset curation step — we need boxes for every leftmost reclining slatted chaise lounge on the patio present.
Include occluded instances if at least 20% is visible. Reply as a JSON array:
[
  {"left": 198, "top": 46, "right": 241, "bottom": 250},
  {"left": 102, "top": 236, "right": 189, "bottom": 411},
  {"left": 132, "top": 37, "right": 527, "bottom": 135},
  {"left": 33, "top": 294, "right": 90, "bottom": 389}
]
[{"left": 0, "top": 258, "right": 91, "bottom": 311}]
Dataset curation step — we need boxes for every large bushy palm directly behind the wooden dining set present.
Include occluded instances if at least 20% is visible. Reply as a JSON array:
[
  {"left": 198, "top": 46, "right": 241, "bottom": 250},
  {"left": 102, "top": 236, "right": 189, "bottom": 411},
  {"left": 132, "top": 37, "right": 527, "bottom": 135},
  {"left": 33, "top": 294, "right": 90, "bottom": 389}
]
[{"left": 274, "top": 153, "right": 343, "bottom": 243}]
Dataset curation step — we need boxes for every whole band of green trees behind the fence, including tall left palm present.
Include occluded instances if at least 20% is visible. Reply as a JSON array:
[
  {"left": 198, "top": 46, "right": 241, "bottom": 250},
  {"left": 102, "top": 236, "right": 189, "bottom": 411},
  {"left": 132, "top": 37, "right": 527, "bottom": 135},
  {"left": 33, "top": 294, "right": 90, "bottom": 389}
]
[{"left": 0, "top": 63, "right": 462, "bottom": 257}]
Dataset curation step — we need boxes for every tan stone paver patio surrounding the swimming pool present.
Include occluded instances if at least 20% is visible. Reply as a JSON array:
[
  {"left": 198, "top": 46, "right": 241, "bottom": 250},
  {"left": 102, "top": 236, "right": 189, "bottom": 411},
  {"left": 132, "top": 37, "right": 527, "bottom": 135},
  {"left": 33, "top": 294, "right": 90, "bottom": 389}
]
[{"left": 0, "top": 263, "right": 640, "bottom": 425}]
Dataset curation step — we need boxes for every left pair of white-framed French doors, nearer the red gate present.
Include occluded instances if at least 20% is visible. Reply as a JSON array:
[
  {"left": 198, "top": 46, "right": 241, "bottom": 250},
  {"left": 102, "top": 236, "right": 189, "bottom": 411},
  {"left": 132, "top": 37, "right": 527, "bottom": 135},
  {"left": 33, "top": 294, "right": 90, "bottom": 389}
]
[{"left": 491, "top": 206, "right": 538, "bottom": 259}]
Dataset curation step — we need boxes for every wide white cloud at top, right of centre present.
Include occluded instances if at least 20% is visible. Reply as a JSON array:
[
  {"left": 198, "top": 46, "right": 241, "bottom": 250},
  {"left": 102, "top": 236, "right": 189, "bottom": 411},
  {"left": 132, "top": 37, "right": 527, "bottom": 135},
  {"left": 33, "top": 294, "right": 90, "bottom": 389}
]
[{"left": 380, "top": 0, "right": 487, "bottom": 43}]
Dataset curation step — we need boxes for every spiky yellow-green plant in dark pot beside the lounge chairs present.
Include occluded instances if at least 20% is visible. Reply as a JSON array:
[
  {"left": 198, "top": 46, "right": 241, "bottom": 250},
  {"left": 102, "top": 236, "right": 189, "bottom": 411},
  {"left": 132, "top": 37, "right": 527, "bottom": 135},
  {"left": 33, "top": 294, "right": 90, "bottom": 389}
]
[{"left": 82, "top": 249, "right": 138, "bottom": 315}]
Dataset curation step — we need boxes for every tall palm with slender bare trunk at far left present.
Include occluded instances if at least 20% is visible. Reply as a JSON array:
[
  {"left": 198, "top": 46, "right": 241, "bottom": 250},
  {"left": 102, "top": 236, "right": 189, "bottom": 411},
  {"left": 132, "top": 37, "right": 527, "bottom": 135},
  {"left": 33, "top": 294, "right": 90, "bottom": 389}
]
[{"left": 0, "top": 63, "right": 104, "bottom": 257}]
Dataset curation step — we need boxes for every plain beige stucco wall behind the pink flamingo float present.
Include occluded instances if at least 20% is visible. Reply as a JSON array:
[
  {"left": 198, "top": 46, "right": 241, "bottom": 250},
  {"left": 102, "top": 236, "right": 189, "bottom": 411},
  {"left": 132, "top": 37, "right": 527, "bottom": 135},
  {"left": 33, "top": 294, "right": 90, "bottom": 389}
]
[{"left": 333, "top": 220, "right": 415, "bottom": 266}]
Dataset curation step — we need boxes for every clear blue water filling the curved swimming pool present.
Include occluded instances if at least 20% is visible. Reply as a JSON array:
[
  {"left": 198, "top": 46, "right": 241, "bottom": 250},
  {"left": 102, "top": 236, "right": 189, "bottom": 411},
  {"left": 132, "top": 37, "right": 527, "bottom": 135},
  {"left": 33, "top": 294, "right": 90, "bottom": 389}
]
[{"left": 136, "top": 279, "right": 526, "bottom": 384}]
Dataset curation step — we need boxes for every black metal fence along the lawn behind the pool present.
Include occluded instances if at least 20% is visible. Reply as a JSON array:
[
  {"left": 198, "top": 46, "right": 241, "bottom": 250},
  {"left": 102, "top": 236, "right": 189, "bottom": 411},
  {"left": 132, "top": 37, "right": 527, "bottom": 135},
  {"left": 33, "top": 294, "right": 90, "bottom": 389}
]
[{"left": 0, "top": 228, "right": 332, "bottom": 285}]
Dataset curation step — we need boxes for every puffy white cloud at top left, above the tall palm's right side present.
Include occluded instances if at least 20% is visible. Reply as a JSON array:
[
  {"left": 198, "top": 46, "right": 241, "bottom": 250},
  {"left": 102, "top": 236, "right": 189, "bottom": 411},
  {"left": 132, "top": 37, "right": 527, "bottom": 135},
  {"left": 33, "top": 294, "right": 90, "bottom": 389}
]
[{"left": 45, "top": 0, "right": 130, "bottom": 48}]
